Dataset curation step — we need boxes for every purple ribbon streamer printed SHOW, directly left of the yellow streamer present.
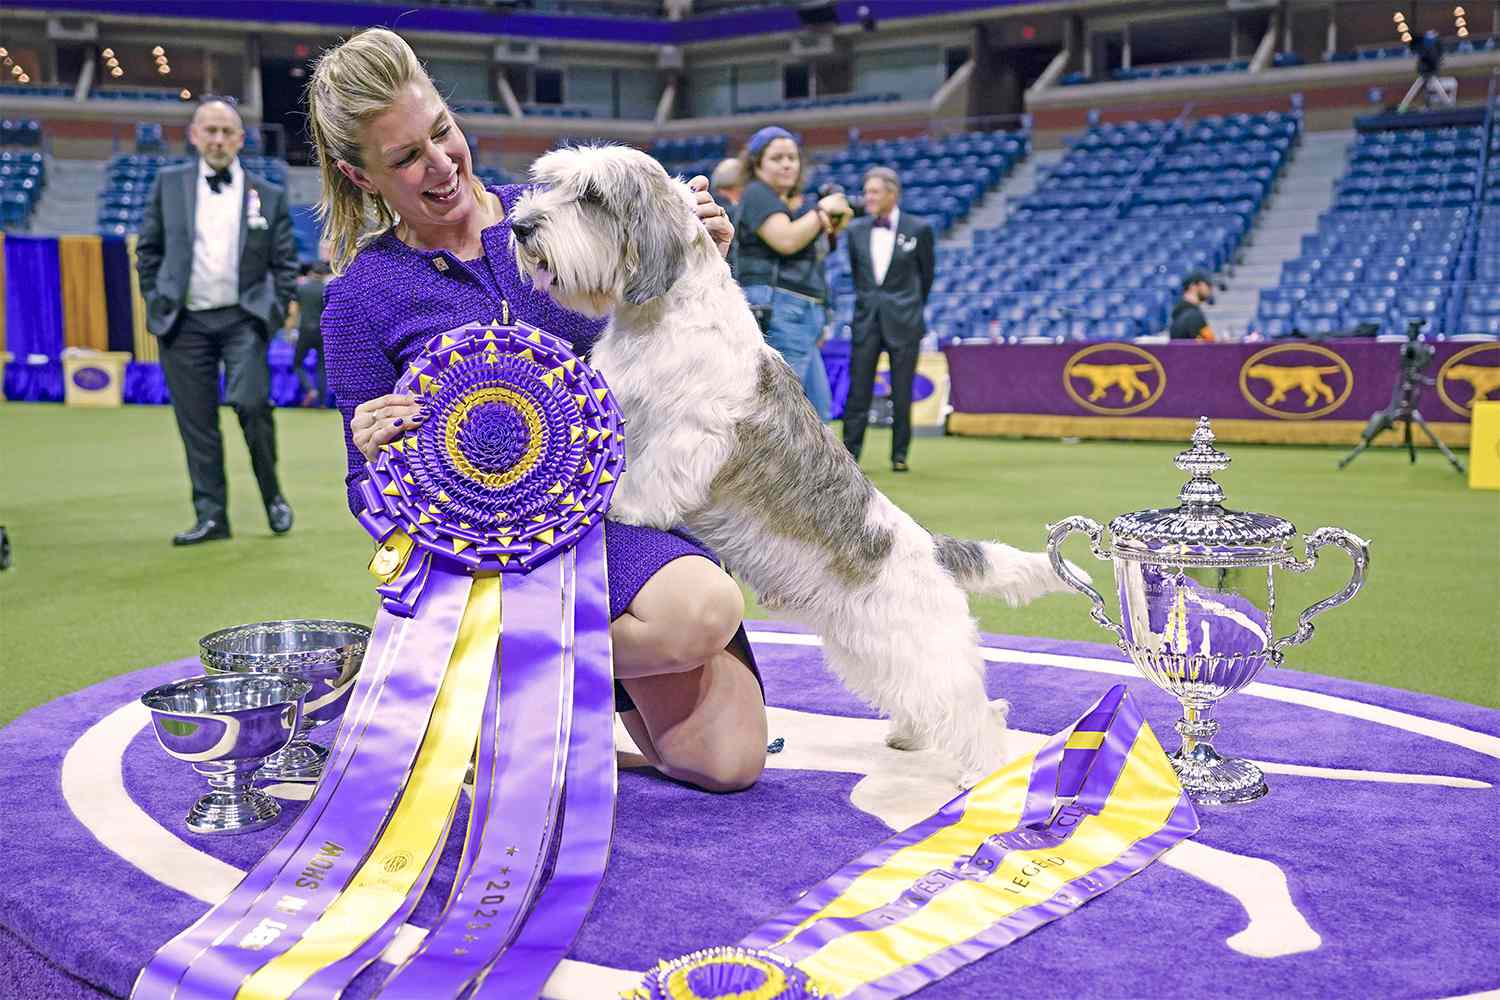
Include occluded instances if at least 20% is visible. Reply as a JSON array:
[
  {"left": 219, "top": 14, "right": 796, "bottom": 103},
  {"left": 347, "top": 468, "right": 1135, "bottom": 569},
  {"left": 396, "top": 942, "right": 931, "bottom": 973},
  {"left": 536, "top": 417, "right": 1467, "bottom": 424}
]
[{"left": 143, "top": 567, "right": 473, "bottom": 1000}]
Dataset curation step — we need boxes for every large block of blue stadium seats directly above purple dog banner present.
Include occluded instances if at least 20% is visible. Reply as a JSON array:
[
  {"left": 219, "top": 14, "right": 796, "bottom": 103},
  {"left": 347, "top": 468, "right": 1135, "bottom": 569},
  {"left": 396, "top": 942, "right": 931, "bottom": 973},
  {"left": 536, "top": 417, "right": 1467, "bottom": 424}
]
[{"left": 882, "top": 112, "right": 1301, "bottom": 340}]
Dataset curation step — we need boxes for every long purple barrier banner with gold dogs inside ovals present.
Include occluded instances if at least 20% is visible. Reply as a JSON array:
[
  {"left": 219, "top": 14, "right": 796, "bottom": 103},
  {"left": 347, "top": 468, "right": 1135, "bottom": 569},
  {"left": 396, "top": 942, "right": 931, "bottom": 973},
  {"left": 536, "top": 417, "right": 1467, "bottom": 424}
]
[{"left": 944, "top": 340, "right": 1500, "bottom": 423}]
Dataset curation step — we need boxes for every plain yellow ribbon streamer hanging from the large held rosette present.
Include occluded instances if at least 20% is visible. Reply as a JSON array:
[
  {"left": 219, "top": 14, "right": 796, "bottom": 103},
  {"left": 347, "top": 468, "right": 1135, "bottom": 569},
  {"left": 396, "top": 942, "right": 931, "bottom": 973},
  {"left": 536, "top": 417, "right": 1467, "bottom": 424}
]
[{"left": 236, "top": 574, "right": 500, "bottom": 1000}]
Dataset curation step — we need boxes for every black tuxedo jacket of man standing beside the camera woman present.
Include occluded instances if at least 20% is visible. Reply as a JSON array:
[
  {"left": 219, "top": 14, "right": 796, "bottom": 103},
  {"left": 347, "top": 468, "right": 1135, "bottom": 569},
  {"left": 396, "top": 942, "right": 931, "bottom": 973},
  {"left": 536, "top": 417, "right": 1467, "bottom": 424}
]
[{"left": 845, "top": 210, "right": 936, "bottom": 343}]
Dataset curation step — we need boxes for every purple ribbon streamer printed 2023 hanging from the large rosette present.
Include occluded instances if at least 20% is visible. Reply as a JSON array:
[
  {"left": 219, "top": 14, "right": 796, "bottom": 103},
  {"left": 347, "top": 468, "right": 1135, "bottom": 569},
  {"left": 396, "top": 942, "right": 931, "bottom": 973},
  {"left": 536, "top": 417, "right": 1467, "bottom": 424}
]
[{"left": 381, "top": 553, "right": 573, "bottom": 1000}]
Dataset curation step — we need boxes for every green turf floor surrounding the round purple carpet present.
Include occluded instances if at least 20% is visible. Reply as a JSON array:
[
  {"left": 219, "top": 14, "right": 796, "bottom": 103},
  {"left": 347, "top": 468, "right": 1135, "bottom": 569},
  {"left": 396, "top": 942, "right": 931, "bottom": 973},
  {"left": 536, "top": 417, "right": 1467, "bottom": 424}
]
[{"left": 0, "top": 403, "right": 1500, "bottom": 724}]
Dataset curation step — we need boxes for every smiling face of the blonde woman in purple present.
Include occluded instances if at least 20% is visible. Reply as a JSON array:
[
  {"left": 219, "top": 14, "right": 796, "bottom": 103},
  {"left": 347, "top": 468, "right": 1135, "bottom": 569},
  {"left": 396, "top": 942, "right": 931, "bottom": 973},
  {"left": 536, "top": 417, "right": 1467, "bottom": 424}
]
[{"left": 345, "top": 84, "right": 480, "bottom": 231}]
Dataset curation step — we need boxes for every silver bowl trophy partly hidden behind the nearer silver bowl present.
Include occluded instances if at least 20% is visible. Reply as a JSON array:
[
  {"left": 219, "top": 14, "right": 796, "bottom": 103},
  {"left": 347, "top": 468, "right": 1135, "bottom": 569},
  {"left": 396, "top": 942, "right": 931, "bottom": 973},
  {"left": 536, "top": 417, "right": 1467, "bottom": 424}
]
[{"left": 198, "top": 618, "right": 371, "bottom": 781}]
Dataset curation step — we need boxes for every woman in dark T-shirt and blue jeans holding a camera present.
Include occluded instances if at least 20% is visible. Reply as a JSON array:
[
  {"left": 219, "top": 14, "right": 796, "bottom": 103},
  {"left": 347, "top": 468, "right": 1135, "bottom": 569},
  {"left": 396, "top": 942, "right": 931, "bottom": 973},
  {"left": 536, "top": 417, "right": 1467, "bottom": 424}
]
[{"left": 735, "top": 124, "right": 854, "bottom": 420}]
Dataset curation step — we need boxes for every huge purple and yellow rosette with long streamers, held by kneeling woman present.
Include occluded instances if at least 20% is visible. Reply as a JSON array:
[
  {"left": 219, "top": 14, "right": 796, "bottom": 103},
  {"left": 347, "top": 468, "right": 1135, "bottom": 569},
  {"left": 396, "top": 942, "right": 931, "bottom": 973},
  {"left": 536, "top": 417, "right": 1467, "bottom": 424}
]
[{"left": 132, "top": 324, "right": 624, "bottom": 1000}]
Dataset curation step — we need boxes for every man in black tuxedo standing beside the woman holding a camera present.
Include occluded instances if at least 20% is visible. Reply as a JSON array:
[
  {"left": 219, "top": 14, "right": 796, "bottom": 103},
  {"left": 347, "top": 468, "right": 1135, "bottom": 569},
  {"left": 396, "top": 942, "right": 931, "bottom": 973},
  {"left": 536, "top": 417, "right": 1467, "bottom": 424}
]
[{"left": 845, "top": 166, "right": 936, "bottom": 472}]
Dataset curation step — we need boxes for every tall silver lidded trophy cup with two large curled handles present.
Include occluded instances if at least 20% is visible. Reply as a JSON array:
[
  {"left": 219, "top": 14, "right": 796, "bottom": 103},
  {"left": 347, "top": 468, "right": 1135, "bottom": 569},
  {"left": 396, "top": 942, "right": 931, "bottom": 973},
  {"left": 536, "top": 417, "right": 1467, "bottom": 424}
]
[{"left": 1047, "top": 417, "right": 1370, "bottom": 805}]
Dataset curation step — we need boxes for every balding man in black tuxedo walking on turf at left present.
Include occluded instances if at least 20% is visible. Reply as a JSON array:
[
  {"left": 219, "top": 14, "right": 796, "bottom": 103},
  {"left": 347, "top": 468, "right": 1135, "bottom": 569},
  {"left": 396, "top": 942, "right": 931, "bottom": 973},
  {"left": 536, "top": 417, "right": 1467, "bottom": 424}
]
[{"left": 137, "top": 99, "right": 297, "bottom": 546}]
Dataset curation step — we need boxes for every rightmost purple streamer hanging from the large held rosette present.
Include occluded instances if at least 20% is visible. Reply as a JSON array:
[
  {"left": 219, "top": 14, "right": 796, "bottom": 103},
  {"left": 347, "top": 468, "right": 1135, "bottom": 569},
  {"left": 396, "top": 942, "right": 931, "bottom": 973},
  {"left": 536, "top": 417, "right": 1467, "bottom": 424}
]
[{"left": 470, "top": 529, "right": 617, "bottom": 1000}]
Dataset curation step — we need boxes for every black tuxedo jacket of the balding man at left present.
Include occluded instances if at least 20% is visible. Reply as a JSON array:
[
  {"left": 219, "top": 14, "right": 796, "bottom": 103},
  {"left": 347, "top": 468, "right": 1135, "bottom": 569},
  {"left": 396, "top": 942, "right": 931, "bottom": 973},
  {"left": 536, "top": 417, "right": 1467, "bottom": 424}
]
[{"left": 135, "top": 159, "right": 297, "bottom": 337}]
